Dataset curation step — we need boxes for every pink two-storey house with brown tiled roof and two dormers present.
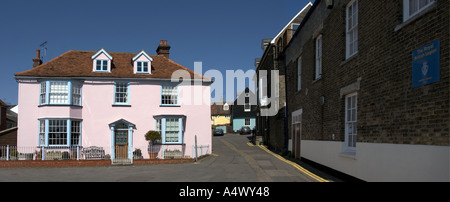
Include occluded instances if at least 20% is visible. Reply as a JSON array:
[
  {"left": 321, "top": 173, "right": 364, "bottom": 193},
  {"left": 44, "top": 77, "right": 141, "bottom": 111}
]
[{"left": 15, "top": 41, "right": 212, "bottom": 162}]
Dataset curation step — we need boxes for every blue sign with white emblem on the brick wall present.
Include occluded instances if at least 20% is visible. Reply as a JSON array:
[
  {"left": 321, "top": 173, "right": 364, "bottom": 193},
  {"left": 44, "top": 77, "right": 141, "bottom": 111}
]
[{"left": 412, "top": 40, "right": 441, "bottom": 88}]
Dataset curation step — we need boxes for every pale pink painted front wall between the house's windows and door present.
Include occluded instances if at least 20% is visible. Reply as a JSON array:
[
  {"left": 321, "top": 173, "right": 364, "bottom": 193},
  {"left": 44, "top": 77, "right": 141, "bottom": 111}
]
[{"left": 18, "top": 81, "right": 212, "bottom": 157}]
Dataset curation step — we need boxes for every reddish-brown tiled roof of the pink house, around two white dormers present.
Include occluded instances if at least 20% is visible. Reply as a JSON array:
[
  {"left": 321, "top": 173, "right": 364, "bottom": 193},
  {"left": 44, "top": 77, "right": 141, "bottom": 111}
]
[{"left": 15, "top": 50, "right": 209, "bottom": 79}]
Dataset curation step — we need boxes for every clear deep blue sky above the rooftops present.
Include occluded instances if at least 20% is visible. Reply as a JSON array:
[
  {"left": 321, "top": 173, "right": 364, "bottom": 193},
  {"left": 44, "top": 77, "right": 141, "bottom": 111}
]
[{"left": 0, "top": 0, "right": 309, "bottom": 104}]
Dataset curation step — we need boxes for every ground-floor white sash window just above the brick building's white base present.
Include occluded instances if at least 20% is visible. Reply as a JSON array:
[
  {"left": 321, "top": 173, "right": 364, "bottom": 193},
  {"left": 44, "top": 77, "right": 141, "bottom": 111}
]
[{"left": 345, "top": 92, "right": 358, "bottom": 152}]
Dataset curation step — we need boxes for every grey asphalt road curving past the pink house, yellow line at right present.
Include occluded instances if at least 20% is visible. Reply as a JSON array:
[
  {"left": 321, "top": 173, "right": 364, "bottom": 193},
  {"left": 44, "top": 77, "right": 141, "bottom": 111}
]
[{"left": 0, "top": 134, "right": 339, "bottom": 182}]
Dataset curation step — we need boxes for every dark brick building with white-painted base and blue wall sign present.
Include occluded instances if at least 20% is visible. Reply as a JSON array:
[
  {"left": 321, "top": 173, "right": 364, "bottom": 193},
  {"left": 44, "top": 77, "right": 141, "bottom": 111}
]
[{"left": 284, "top": 0, "right": 450, "bottom": 181}]
